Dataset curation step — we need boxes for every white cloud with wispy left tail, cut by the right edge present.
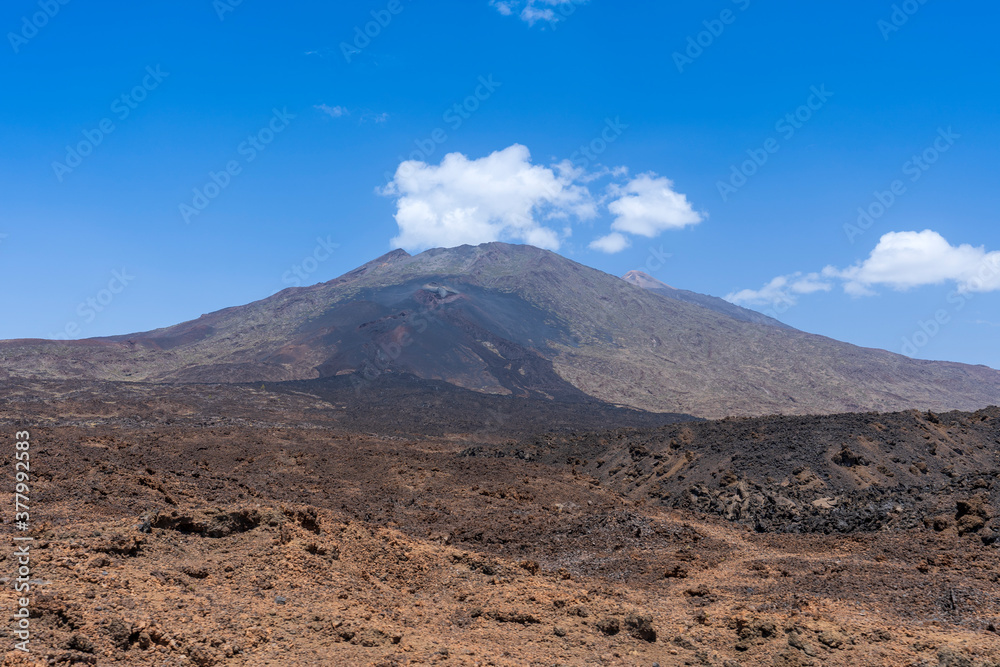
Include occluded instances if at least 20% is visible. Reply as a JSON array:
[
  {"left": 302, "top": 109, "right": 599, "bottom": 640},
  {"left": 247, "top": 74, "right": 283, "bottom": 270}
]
[{"left": 726, "top": 229, "right": 1000, "bottom": 305}]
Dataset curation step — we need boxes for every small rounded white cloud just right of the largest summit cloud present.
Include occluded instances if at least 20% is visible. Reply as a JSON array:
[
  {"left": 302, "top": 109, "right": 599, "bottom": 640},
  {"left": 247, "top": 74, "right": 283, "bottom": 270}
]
[{"left": 608, "top": 173, "right": 702, "bottom": 238}]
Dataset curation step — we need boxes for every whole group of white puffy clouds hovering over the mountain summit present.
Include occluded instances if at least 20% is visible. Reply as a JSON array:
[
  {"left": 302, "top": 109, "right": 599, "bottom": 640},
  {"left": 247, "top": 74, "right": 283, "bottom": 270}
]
[{"left": 378, "top": 144, "right": 702, "bottom": 254}]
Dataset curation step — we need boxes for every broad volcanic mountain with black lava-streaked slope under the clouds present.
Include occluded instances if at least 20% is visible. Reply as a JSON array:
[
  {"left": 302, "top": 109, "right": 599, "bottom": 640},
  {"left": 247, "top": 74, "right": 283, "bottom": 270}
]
[{"left": 0, "top": 243, "right": 1000, "bottom": 417}]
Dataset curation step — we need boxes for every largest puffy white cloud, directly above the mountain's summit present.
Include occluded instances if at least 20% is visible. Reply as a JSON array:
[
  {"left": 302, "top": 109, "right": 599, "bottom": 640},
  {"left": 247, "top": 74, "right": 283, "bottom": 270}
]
[{"left": 379, "top": 144, "right": 597, "bottom": 250}]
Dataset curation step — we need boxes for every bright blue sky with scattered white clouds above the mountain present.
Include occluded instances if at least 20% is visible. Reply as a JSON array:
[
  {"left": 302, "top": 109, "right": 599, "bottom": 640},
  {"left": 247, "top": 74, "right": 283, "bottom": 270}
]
[{"left": 0, "top": 0, "right": 1000, "bottom": 368}]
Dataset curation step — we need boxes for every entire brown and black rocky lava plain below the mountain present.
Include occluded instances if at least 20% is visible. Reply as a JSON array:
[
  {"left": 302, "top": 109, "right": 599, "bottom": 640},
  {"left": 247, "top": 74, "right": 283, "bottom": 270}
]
[{"left": 0, "top": 381, "right": 1000, "bottom": 667}]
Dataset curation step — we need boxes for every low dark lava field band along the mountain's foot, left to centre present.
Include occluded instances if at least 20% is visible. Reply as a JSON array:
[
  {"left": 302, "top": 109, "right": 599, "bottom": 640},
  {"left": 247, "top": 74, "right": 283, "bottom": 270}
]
[{"left": 0, "top": 373, "right": 700, "bottom": 437}]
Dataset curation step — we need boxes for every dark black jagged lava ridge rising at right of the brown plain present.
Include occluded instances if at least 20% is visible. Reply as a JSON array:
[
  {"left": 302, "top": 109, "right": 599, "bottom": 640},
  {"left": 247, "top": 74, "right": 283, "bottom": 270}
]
[{"left": 466, "top": 407, "right": 1000, "bottom": 544}]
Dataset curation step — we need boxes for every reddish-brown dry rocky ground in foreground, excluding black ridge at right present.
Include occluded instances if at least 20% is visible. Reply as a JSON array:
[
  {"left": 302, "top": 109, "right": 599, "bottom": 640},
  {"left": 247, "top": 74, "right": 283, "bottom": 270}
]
[{"left": 0, "top": 380, "right": 1000, "bottom": 667}]
